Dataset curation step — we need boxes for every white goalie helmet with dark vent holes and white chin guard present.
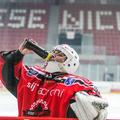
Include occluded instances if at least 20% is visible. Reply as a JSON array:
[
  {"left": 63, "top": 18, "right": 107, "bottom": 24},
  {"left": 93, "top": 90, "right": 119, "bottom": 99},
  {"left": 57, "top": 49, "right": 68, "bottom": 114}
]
[{"left": 46, "top": 44, "right": 79, "bottom": 74}]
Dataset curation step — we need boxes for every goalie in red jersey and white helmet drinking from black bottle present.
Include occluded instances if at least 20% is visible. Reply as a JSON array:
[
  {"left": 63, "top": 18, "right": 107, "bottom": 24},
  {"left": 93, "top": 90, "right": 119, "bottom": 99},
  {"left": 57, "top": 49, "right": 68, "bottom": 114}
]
[{"left": 0, "top": 39, "right": 108, "bottom": 120}]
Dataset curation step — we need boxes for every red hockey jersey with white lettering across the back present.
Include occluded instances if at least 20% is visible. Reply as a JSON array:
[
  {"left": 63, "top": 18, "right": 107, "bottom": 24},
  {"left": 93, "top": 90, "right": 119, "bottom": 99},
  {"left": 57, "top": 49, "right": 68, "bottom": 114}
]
[{"left": 0, "top": 50, "right": 100, "bottom": 117}]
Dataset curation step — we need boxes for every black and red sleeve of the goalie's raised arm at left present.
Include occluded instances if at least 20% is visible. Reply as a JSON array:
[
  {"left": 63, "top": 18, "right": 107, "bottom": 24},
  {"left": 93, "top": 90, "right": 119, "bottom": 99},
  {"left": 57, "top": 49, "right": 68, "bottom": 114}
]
[{"left": 0, "top": 50, "right": 23, "bottom": 96}]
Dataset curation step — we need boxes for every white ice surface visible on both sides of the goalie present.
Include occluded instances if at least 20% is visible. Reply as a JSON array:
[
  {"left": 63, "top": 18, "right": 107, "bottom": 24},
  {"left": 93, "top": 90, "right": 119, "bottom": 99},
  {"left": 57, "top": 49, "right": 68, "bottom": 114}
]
[{"left": 0, "top": 92, "right": 120, "bottom": 119}]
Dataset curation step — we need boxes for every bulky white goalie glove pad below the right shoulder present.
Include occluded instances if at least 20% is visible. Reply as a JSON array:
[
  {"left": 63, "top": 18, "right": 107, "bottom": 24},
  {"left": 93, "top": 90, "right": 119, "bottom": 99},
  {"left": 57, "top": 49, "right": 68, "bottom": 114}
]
[{"left": 70, "top": 92, "right": 108, "bottom": 120}]
